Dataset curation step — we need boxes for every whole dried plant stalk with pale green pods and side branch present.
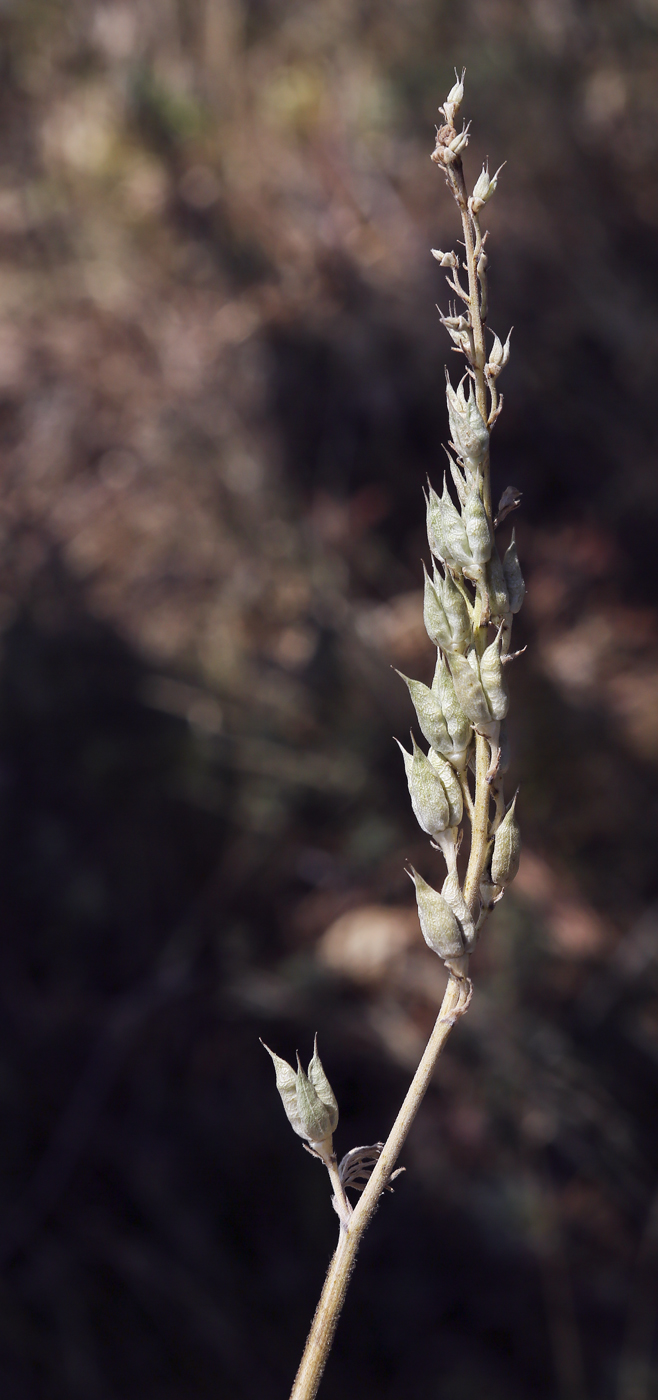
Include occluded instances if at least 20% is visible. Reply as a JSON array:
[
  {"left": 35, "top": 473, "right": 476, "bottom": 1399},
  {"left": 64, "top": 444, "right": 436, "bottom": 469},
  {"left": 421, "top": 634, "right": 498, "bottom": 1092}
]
[{"left": 261, "top": 73, "right": 525, "bottom": 1400}]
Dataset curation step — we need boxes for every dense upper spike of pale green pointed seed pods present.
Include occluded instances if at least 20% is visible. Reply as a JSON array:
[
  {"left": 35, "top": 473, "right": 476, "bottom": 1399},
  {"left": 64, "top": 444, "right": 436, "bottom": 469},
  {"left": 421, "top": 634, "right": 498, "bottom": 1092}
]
[{"left": 392, "top": 74, "right": 525, "bottom": 976}]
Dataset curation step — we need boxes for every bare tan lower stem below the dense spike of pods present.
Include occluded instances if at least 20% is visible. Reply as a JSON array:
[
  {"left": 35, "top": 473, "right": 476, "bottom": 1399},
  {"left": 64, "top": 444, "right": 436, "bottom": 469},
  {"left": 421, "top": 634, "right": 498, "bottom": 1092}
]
[{"left": 290, "top": 974, "right": 470, "bottom": 1400}]
